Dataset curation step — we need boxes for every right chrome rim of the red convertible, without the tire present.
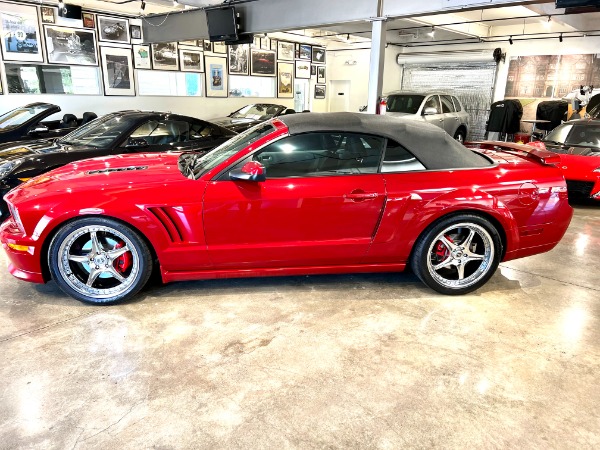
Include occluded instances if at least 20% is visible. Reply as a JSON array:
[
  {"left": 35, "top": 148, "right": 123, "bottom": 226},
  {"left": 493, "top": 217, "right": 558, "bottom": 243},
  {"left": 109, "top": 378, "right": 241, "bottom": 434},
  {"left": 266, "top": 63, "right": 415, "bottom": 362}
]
[{"left": 427, "top": 222, "right": 495, "bottom": 289}]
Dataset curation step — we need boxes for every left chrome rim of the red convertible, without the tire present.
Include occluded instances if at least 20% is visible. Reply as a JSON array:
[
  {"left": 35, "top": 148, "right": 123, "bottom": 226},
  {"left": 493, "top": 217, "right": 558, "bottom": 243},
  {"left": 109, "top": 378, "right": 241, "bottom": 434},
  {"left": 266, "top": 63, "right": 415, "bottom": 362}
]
[{"left": 57, "top": 225, "right": 140, "bottom": 300}]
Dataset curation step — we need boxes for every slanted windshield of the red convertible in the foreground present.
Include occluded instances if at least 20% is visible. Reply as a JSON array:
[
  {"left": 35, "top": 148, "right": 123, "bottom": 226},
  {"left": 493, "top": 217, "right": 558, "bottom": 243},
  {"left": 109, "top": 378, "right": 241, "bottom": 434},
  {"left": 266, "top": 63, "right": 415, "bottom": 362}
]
[{"left": 179, "top": 123, "right": 275, "bottom": 180}]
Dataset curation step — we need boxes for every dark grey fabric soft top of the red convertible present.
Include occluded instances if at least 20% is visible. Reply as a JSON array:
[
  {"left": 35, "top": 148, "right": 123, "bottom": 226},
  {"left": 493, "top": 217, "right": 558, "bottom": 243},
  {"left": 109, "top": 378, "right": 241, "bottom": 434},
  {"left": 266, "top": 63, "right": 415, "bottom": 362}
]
[{"left": 279, "top": 113, "right": 490, "bottom": 170}]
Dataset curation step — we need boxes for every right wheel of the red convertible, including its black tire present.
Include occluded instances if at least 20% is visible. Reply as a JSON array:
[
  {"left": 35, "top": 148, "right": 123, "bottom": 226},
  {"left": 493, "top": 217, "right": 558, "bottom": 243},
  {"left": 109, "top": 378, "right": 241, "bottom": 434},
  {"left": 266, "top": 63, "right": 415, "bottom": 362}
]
[{"left": 410, "top": 213, "right": 502, "bottom": 295}]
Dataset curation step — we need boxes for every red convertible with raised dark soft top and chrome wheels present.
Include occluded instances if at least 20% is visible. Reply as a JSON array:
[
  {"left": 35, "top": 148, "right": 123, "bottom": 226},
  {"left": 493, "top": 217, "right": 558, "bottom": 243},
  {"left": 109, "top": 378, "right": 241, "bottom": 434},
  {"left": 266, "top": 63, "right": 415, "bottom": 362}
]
[{"left": 0, "top": 113, "right": 573, "bottom": 303}]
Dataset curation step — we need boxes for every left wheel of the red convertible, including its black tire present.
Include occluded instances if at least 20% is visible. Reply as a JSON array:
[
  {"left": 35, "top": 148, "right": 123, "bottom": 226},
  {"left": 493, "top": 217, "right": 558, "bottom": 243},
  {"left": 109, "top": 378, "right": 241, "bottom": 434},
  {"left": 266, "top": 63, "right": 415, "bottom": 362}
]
[{"left": 48, "top": 217, "right": 152, "bottom": 304}]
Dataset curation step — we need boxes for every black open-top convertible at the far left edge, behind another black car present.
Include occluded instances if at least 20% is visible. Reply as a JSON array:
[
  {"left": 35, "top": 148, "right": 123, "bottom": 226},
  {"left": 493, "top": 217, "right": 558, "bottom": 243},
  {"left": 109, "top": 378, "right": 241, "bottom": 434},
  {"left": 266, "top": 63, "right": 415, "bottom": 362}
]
[{"left": 0, "top": 103, "right": 97, "bottom": 143}]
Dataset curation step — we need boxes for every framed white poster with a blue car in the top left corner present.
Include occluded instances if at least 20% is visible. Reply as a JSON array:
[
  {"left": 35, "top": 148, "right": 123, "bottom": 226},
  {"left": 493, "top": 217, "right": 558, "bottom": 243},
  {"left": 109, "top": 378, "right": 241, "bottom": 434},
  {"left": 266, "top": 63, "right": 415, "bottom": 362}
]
[{"left": 0, "top": 3, "right": 44, "bottom": 62}]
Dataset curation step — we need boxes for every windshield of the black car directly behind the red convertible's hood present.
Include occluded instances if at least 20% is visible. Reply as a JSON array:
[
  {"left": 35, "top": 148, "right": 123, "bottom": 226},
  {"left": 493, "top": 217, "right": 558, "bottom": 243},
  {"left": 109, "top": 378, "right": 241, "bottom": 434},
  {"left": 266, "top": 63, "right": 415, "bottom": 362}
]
[{"left": 58, "top": 114, "right": 138, "bottom": 148}]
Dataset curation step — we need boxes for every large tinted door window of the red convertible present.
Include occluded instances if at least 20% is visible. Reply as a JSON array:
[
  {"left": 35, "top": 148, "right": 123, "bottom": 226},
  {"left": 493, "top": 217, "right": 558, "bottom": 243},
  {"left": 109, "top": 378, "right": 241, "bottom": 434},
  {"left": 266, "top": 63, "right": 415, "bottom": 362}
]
[{"left": 252, "top": 132, "right": 385, "bottom": 178}]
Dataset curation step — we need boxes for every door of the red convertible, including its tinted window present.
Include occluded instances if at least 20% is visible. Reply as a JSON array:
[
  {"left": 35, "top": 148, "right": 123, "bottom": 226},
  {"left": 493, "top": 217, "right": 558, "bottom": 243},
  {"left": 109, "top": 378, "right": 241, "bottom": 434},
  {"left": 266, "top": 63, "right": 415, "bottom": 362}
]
[{"left": 203, "top": 132, "right": 385, "bottom": 268}]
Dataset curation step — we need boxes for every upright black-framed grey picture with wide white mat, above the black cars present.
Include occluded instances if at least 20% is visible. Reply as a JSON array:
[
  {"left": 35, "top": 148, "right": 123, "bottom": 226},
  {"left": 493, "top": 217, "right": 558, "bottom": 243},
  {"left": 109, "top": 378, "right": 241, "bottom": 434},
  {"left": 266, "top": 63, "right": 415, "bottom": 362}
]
[{"left": 100, "top": 47, "right": 135, "bottom": 96}]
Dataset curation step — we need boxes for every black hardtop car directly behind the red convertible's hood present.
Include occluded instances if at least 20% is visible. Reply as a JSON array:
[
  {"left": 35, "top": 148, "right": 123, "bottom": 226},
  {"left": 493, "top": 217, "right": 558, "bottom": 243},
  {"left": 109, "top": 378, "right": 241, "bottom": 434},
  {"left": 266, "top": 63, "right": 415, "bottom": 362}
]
[{"left": 0, "top": 111, "right": 236, "bottom": 222}]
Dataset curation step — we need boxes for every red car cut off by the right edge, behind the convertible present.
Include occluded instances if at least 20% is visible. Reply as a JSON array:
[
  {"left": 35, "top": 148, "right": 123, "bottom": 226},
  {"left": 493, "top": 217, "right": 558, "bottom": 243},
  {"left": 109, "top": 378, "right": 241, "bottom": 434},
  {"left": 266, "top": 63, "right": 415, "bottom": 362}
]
[{"left": 542, "top": 119, "right": 600, "bottom": 200}]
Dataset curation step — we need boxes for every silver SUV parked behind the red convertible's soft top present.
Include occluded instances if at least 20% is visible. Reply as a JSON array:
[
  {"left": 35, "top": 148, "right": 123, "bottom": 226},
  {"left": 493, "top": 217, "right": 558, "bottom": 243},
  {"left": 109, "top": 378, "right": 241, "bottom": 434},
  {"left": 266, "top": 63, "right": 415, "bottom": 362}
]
[{"left": 382, "top": 91, "right": 469, "bottom": 142}]
